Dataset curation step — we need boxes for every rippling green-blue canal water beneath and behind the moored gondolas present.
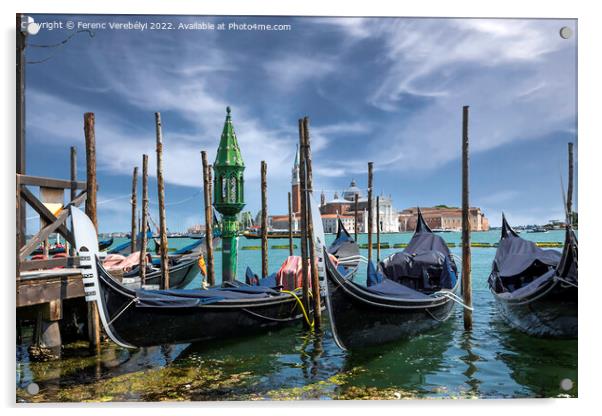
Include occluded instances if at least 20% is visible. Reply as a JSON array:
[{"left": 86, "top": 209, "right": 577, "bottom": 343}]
[{"left": 16, "top": 230, "right": 577, "bottom": 402}]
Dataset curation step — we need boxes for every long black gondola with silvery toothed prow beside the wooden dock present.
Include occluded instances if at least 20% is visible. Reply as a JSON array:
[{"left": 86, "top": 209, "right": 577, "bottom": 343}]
[{"left": 70, "top": 207, "right": 312, "bottom": 348}]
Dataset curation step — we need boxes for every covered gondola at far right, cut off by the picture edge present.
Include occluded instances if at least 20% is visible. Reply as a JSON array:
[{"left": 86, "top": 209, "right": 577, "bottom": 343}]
[{"left": 488, "top": 215, "right": 578, "bottom": 338}]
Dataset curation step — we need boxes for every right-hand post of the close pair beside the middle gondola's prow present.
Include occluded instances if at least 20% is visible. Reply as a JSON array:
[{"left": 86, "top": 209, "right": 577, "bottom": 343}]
[{"left": 302, "top": 117, "right": 322, "bottom": 329}]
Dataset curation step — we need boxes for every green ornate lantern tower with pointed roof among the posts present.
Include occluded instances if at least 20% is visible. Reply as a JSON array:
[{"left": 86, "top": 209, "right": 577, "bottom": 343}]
[{"left": 213, "top": 107, "right": 245, "bottom": 281}]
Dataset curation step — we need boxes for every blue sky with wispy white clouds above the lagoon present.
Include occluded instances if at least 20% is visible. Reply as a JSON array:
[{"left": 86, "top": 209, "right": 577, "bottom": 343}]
[{"left": 25, "top": 15, "right": 578, "bottom": 232}]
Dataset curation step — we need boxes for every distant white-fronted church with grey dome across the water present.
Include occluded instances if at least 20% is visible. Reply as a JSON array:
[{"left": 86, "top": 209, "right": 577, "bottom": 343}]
[{"left": 320, "top": 180, "right": 399, "bottom": 233}]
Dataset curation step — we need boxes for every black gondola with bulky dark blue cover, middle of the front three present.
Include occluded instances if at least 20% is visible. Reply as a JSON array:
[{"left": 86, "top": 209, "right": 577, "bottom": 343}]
[{"left": 325, "top": 211, "right": 460, "bottom": 350}]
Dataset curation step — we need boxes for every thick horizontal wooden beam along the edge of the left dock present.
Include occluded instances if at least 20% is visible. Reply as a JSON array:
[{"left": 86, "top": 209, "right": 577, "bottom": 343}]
[{"left": 16, "top": 274, "right": 84, "bottom": 308}]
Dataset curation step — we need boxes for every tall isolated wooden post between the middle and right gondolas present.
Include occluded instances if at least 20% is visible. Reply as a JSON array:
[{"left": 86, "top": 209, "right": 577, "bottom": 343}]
[{"left": 462, "top": 105, "right": 472, "bottom": 331}]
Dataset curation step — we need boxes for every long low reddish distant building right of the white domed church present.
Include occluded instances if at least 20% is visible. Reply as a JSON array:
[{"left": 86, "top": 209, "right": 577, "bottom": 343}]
[{"left": 399, "top": 206, "right": 489, "bottom": 231}]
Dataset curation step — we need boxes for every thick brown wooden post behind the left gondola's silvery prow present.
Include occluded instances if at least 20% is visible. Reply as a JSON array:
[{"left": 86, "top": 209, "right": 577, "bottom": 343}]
[{"left": 84, "top": 113, "right": 100, "bottom": 354}]
